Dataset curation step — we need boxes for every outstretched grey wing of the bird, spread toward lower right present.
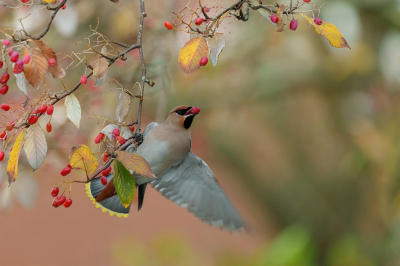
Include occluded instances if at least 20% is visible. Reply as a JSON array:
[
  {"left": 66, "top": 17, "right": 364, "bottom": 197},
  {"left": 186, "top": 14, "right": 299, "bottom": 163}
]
[{"left": 151, "top": 152, "right": 245, "bottom": 231}]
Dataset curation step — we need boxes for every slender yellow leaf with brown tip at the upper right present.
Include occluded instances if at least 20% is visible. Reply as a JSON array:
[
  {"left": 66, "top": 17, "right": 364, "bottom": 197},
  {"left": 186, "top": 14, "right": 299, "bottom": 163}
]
[{"left": 300, "top": 13, "right": 351, "bottom": 49}]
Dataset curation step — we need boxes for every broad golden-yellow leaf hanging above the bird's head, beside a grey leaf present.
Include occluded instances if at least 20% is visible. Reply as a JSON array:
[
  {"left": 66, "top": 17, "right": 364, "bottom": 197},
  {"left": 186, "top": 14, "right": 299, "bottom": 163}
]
[{"left": 178, "top": 37, "right": 208, "bottom": 75}]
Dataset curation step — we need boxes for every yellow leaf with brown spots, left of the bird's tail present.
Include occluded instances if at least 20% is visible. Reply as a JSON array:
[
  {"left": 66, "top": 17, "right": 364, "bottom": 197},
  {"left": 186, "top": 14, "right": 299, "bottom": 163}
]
[{"left": 69, "top": 145, "right": 99, "bottom": 175}]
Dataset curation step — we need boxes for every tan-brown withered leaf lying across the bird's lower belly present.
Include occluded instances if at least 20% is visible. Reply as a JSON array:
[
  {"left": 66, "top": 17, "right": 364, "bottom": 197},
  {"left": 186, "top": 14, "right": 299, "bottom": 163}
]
[{"left": 116, "top": 151, "right": 156, "bottom": 178}]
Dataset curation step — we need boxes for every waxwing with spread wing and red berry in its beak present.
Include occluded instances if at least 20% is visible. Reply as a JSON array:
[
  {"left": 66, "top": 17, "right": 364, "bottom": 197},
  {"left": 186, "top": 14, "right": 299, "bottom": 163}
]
[{"left": 86, "top": 105, "right": 244, "bottom": 231}]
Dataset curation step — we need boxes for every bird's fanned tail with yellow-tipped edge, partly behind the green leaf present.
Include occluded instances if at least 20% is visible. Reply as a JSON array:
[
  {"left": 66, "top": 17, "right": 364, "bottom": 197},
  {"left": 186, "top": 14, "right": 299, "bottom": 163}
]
[{"left": 85, "top": 173, "right": 152, "bottom": 218}]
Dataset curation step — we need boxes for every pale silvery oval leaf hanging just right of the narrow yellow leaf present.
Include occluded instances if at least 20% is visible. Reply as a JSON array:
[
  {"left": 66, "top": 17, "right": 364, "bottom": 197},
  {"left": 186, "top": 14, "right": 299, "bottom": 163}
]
[{"left": 24, "top": 123, "right": 47, "bottom": 171}]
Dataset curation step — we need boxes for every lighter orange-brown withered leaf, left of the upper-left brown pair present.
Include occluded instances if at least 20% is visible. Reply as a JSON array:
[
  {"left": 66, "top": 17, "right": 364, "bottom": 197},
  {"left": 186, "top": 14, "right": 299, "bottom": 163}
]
[{"left": 22, "top": 46, "right": 49, "bottom": 89}]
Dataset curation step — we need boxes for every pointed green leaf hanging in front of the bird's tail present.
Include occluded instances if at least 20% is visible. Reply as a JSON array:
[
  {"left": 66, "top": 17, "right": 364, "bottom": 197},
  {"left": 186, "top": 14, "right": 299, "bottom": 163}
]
[{"left": 114, "top": 159, "right": 136, "bottom": 208}]
